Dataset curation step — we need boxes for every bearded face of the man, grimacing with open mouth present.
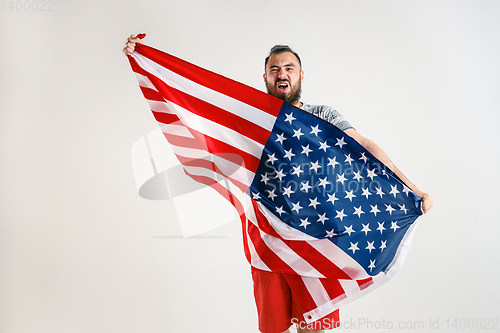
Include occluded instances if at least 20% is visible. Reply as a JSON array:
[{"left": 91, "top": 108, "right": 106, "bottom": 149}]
[{"left": 264, "top": 52, "right": 304, "bottom": 106}]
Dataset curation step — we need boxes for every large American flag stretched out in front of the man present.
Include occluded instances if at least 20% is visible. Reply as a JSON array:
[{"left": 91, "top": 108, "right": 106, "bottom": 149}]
[{"left": 129, "top": 44, "right": 422, "bottom": 322}]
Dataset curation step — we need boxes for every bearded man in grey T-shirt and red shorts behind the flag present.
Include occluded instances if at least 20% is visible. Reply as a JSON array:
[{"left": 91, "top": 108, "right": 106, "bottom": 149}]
[{"left": 123, "top": 35, "right": 433, "bottom": 333}]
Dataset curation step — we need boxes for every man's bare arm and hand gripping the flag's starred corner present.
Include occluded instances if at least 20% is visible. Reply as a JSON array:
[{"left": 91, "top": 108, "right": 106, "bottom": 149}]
[{"left": 345, "top": 128, "right": 434, "bottom": 213}]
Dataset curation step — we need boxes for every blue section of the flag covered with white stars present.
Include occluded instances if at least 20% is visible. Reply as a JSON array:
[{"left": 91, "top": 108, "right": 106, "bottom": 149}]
[{"left": 248, "top": 104, "right": 422, "bottom": 275}]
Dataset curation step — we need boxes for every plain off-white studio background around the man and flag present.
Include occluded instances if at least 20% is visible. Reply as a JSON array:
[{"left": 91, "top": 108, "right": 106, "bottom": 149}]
[{"left": 0, "top": 0, "right": 500, "bottom": 333}]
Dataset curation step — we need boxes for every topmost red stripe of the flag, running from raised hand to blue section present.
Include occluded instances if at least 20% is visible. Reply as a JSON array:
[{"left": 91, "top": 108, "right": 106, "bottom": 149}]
[{"left": 133, "top": 44, "right": 283, "bottom": 116}]
